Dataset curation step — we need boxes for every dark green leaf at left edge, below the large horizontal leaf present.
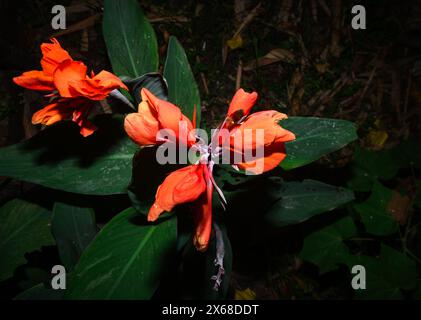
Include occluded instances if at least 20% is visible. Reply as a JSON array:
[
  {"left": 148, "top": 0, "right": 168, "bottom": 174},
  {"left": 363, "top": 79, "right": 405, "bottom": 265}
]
[{"left": 0, "top": 199, "right": 54, "bottom": 281}]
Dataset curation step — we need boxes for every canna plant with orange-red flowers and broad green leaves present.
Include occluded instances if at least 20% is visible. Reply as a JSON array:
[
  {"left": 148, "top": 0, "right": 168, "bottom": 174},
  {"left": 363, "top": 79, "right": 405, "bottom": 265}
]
[{"left": 0, "top": 0, "right": 357, "bottom": 299}]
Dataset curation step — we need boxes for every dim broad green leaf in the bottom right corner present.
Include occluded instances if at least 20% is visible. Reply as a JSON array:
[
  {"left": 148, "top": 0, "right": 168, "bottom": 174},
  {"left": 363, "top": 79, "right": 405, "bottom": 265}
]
[{"left": 347, "top": 245, "right": 417, "bottom": 300}]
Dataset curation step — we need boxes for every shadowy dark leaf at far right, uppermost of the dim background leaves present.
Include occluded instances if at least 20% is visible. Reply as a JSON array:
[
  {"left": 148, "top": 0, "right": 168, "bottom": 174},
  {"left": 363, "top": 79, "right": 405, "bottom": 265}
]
[{"left": 348, "top": 147, "right": 400, "bottom": 192}]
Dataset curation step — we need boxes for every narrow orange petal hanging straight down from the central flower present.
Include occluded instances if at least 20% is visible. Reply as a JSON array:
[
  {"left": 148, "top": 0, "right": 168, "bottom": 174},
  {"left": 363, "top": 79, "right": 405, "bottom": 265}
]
[{"left": 193, "top": 166, "right": 213, "bottom": 251}]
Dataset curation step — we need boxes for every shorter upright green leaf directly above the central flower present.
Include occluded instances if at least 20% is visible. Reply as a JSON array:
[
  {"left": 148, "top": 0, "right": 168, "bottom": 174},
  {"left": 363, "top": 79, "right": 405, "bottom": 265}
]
[{"left": 164, "top": 37, "right": 200, "bottom": 127}]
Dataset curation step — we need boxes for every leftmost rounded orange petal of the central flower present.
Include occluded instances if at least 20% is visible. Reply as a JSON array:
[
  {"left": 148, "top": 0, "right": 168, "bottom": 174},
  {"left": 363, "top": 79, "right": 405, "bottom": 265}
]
[{"left": 124, "top": 101, "right": 159, "bottom": 145}]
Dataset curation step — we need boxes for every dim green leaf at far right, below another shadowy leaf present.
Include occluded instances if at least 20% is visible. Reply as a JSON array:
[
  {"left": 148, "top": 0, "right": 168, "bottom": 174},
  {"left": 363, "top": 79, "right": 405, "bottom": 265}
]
[{"left": 354, "top": 182, "right": 398, "bottom": 236}]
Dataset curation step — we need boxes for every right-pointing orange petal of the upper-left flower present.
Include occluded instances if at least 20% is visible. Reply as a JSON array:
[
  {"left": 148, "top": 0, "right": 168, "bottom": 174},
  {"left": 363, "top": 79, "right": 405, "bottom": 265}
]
[{"left": 69, "top": 70, "right": 128, "bottom": 100}]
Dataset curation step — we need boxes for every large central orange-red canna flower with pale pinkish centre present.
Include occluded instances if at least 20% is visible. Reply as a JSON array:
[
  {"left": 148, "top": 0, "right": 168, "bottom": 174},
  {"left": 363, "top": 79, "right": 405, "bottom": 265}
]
[{"left": 124, "top": 89, "right": 295, "bottom": 251}]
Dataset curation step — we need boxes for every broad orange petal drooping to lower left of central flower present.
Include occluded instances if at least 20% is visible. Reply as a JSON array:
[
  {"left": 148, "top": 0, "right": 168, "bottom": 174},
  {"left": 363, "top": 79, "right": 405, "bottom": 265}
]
[{"left": 148, "top": 165, "right": 206, "bottom": 221}]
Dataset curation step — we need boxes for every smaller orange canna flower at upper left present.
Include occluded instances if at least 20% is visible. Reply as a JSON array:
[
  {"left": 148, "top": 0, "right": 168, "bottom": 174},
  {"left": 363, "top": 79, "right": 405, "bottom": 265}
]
[{"left": 13, "top": 38, "right": 127, "bottom": 137}]
